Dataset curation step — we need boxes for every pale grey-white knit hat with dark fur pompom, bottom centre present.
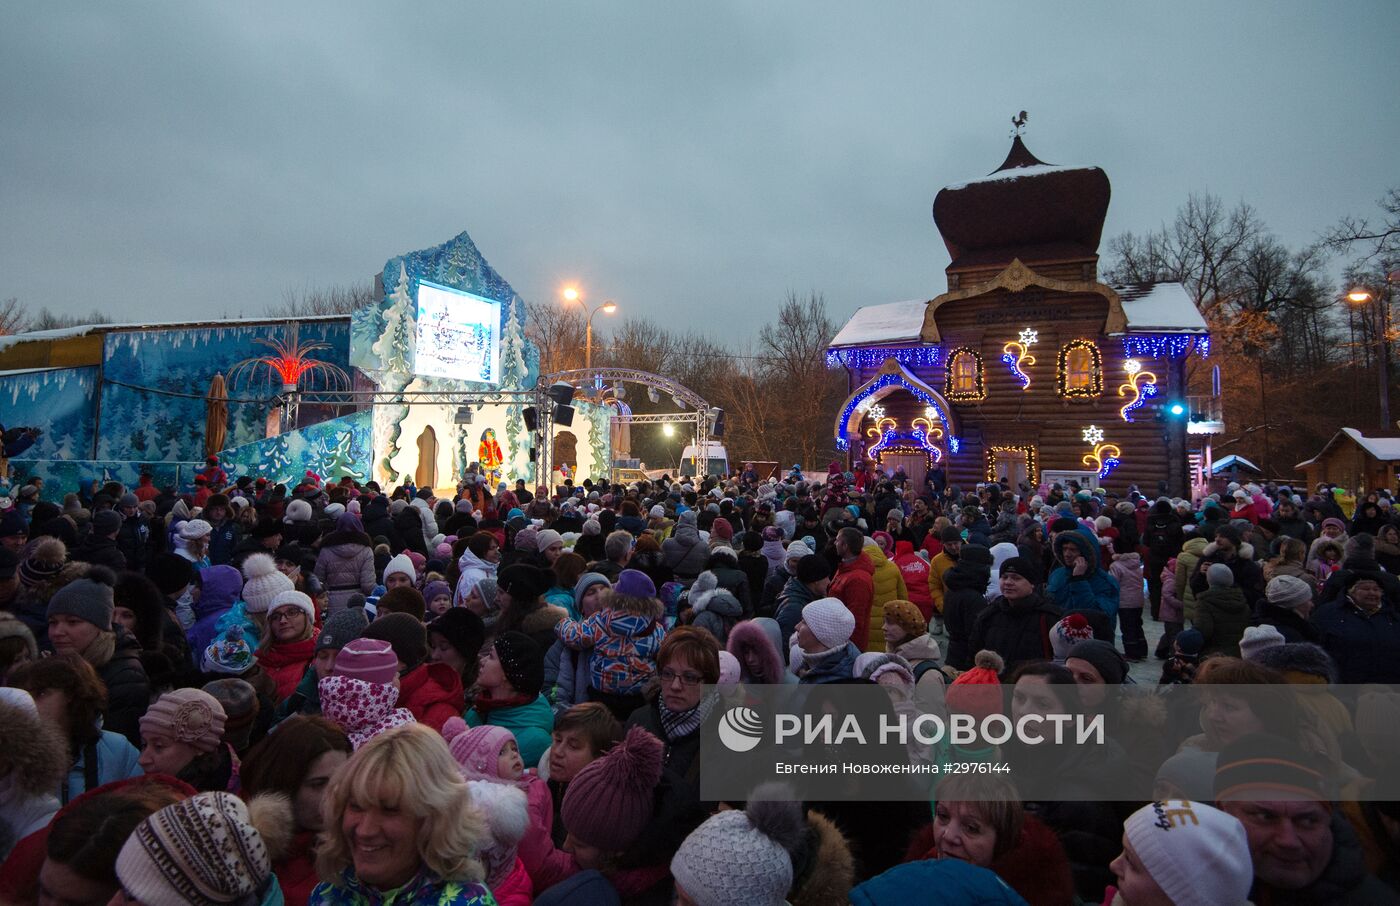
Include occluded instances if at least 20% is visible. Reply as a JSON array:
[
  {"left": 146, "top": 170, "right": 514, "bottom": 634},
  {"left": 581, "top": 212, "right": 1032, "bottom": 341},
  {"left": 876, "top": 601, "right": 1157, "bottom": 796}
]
[{"left": 671, "top": 784, "right": 806, "bottom": 906}]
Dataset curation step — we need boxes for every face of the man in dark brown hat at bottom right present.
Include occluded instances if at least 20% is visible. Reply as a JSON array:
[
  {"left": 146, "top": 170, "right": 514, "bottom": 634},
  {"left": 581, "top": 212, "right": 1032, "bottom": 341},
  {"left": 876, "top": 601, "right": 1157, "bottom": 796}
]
[{"left": 1221, "top": 800, "right": 1333, "bottom": 891}]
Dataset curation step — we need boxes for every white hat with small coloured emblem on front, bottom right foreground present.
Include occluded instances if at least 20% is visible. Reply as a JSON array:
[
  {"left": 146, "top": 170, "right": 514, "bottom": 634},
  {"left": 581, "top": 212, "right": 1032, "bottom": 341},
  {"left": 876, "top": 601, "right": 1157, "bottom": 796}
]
[{"left": 1123, "top": 800, "right": 1254, "bottom": 906}]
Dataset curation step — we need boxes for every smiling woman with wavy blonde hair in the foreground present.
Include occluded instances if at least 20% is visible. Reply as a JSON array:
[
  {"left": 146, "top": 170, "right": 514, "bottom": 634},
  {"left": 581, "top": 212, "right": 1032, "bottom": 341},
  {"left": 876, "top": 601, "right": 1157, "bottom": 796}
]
[{"left": 308, "top": 724, "right": 494, "bottom": 906}]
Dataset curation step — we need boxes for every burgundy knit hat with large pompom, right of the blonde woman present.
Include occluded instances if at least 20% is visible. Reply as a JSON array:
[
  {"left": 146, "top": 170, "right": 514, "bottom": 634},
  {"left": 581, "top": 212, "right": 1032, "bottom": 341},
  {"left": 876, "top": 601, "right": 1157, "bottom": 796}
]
[{"left": 560, "top": 727, "right": 665, "bottom": 853}]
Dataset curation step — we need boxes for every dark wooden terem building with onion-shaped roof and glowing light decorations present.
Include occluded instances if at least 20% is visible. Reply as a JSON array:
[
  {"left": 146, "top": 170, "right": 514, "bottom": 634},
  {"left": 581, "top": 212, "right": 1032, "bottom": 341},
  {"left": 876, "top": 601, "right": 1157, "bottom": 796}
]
[{"left": 827, "top": 136, "right": 1210, "bottom": 496}]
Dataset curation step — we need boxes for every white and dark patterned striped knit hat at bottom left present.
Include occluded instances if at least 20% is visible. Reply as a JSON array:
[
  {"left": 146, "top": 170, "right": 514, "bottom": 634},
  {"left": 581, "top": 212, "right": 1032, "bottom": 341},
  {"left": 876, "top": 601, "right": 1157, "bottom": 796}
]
[{"left": 116, "top": 793, "right": 272, "bottom": 906}]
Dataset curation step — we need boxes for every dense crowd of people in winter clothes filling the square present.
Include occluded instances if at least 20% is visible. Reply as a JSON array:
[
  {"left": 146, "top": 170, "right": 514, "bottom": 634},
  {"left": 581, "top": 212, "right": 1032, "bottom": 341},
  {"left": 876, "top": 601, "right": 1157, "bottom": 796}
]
[{"left": 0, "top": 459, "right": 1400, "bottom": 906}]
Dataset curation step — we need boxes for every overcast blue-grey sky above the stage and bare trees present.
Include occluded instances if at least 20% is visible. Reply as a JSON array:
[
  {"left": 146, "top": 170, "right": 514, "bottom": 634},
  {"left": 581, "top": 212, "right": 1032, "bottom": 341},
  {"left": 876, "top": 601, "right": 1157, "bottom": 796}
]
[{"left": 0, "top": 0, "right": 1400, "bottom": 334}]
